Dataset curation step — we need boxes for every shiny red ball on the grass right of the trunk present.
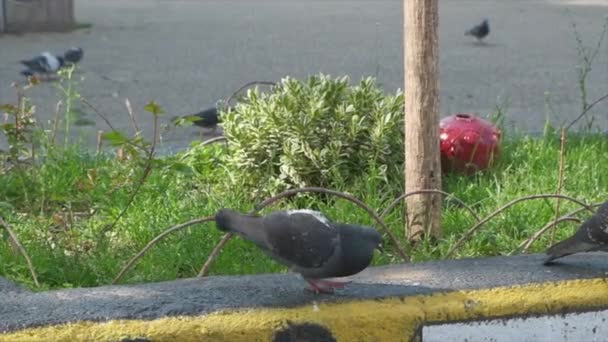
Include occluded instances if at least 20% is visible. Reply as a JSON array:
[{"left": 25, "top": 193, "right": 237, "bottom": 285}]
[{"left": 439, "top": 114, "right": 500, "bottom": 174}]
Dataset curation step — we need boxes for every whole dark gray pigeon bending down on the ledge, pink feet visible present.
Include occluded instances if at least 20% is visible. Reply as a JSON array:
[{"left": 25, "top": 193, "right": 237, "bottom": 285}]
[{"left": 215, "top": 209, "right": 382, "bottom": 293}]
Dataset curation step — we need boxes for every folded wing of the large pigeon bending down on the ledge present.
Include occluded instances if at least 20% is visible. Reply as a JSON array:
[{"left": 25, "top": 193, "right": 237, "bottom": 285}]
[{"left": 263, "top": 210, "right": 340, "bottom": 268}]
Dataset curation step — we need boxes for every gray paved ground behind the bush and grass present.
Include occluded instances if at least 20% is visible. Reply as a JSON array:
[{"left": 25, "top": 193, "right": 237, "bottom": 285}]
[{"left": 0, "top": 0, "right": 608, "bottom": 148}]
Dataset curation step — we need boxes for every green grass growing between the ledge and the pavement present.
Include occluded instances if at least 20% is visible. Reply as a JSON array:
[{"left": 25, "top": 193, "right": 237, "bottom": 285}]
[{"left": 0, "top": 135, "right": 608, "bottom": 289}]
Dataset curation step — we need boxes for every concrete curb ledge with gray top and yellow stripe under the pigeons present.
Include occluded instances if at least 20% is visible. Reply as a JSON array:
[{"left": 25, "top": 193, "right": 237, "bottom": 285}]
[{"left": 0, "top": 253, "right": 608, "bottom": 341}]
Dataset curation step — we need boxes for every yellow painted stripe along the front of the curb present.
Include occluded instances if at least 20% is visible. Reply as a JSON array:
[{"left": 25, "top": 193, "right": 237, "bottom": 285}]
[{"left": 0, "top": 279, "right": 608, "bottom": 342}]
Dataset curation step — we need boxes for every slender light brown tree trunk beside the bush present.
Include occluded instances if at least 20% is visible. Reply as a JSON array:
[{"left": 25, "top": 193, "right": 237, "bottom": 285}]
[{"left": 403, "top": 0, "right": 441, "bottom": 240}]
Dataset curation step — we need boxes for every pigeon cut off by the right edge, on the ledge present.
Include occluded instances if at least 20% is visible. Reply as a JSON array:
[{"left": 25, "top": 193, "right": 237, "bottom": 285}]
[{"left": 545, "top": 202, "right": 608, "bottom": 265}]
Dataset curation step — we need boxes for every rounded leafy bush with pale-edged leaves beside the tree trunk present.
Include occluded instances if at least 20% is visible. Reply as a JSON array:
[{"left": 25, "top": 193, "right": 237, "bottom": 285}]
[{"left": 221, "top": 75, "right": 403, "bottom": 198}]
